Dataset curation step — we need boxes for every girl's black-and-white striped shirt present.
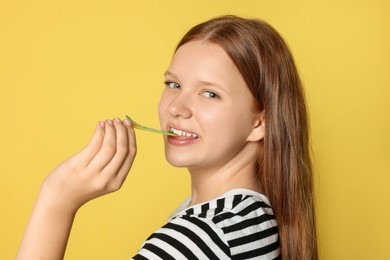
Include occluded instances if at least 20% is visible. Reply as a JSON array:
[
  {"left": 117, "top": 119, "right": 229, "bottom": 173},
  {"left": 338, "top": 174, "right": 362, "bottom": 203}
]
[{"left": 133, "top": 189, "right": 280, "bottom": 260}]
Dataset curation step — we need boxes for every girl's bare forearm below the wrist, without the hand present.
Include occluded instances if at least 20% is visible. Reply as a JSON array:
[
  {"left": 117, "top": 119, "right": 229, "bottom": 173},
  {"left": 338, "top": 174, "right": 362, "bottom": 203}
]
[{"left": 16, "top": 187, "right": 76, "bottom": 260}]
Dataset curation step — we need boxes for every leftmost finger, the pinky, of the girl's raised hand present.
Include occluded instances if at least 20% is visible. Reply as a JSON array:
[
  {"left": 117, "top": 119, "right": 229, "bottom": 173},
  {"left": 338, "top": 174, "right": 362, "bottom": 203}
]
[{"left": 79, "top": 121, "right": 106, "bottom": 165}]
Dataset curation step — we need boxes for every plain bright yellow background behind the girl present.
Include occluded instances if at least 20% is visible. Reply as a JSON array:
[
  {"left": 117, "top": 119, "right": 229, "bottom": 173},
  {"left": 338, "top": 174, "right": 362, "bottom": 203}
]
[{"left": 0, "top": 0, "right": 390, "bottom": 260}]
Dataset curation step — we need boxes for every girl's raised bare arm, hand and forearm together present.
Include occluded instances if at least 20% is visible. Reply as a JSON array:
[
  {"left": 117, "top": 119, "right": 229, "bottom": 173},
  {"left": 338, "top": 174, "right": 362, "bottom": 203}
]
[{"left": 16, "top": 119, "right": 137, "bottom": 260}]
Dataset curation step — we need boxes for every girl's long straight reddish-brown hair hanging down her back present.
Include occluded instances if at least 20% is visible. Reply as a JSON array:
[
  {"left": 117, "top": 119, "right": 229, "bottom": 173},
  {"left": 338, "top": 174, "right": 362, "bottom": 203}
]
[{"left": 177, "top": 16, "right": 318, "bottom": 260}]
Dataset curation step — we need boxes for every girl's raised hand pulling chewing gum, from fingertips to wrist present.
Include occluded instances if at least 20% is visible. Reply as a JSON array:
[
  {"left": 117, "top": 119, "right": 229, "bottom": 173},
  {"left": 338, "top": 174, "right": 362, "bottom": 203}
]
[{"left": 42, "top": 119, "right": 136, "bottom": 210}]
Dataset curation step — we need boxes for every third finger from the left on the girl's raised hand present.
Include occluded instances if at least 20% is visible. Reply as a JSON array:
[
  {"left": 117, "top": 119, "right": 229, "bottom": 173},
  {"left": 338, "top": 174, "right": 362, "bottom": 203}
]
[{"left": 102, "top": 118, "right": 129, "bottom": 179}]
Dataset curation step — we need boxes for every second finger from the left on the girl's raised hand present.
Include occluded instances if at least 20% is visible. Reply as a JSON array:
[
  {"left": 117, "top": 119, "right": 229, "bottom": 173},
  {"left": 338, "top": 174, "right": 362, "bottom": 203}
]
[{"left": 88, "top": 120, "right": 116, "bottom": 172}]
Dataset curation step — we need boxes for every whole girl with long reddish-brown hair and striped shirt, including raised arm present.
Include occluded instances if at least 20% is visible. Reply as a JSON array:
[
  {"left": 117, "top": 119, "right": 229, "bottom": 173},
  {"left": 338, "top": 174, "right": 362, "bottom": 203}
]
[{"left": 17, "top": 16, "right": 317, "bottom": 260}]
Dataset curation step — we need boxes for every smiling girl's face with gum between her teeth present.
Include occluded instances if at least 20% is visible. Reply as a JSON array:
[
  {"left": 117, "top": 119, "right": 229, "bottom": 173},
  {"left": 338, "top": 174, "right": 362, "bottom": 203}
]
[{"left": 158, "top": 41, "right": 259, "bottom": 171}]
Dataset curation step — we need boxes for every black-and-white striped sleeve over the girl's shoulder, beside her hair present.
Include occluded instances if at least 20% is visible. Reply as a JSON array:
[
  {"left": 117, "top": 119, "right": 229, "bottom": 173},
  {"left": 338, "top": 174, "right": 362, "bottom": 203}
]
[{"left": 212, "top": 194, "right": 280, "bottom": 259}]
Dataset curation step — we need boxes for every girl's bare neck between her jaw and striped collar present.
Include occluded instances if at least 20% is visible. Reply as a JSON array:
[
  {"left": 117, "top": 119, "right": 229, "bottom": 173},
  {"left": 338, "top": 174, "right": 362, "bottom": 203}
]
[{"left": 189, "top": 143, "right": 261, "bottom": 206}]
